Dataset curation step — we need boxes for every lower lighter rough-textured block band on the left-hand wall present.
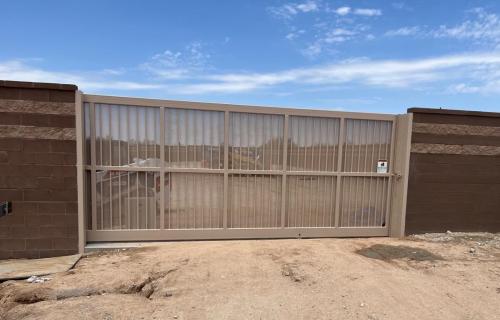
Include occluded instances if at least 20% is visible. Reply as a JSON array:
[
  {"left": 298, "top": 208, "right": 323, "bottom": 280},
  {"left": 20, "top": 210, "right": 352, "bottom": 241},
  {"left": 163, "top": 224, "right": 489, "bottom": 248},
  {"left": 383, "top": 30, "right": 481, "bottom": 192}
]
[{"left": 0, "top": 125, "right": 76, "bottom": 140}]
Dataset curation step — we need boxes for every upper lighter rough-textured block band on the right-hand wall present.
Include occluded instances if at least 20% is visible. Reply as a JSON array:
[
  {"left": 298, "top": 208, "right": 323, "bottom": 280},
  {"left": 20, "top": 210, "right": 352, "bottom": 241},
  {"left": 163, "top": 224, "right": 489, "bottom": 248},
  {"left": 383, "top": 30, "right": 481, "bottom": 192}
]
[{"left": 413, "top": 123, "right": 500, "bottom": 137}]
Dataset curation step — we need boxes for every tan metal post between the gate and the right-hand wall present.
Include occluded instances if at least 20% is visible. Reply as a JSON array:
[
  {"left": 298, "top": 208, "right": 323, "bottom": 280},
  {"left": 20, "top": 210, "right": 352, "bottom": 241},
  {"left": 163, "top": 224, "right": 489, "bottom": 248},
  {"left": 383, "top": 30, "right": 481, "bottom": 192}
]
[{"left": 389, "top": 113, "right": 413, "bottom": 238}]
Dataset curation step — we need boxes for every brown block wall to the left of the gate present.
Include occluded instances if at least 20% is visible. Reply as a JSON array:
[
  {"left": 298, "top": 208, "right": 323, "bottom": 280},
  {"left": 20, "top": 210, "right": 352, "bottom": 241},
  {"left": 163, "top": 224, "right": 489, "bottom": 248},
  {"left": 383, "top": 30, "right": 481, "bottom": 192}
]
[{"left": 0, "top": 81, "right": 78, "bottom": 259}]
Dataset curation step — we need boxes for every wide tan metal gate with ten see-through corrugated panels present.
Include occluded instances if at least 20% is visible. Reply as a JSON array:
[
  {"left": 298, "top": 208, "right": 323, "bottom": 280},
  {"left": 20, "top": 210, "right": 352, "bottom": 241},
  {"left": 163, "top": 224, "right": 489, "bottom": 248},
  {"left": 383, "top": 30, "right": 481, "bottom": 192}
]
[{"left": 77, "top": 94, "right": 411, "bottom": 242}]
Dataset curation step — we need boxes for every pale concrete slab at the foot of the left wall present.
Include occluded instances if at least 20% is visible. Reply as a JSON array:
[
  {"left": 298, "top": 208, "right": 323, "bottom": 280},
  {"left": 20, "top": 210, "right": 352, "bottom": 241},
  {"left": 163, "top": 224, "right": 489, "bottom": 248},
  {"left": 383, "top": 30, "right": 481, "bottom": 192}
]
[{"left": 0, "top": 254, "right": 82, "bottom": 281}]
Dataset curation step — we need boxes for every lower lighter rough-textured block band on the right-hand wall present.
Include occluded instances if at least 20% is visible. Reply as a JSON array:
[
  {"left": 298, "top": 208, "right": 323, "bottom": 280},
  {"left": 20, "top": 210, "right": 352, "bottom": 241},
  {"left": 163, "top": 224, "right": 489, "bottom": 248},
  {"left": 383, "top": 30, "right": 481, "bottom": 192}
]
[{"left": 411, "top": 143, "right": 500, "bottom": 156}]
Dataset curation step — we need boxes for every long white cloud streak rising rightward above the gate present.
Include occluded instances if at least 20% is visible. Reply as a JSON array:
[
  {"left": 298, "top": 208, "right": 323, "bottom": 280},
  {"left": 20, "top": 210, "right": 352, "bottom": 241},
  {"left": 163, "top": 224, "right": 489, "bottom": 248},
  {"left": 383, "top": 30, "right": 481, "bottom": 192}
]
[{"left": 171, "top": 53, "right": 500, "bottom": 94}]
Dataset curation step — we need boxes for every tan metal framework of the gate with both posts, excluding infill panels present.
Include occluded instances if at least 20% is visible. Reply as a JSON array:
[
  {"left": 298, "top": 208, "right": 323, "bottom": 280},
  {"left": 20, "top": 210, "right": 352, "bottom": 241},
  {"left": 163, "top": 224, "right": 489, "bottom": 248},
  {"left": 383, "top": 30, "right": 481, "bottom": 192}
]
[{"left": 75, "top": 91, "right": 412, "bottom": 248}]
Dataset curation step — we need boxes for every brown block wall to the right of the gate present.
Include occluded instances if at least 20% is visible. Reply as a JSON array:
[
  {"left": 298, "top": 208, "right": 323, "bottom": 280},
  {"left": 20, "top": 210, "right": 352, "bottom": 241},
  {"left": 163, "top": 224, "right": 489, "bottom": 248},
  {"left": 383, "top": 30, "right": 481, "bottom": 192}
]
[{"left": 406, "top": 108, "right": 500, "bottom": 234}]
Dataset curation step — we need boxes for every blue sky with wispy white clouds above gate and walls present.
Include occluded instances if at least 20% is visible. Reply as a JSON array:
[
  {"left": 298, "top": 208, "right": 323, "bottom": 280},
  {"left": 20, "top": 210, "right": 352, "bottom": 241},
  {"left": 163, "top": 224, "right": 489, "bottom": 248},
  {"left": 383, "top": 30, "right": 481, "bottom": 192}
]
[{"left": 0, "top": 0, "right": 500, "bottom": 113}]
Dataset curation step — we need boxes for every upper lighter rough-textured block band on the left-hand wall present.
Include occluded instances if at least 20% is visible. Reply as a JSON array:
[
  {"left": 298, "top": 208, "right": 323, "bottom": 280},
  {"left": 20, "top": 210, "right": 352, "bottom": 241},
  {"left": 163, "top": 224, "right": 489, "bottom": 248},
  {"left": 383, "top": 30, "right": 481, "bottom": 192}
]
[{"left": 0, "top": 99, "right": 75, "bottom": 115}]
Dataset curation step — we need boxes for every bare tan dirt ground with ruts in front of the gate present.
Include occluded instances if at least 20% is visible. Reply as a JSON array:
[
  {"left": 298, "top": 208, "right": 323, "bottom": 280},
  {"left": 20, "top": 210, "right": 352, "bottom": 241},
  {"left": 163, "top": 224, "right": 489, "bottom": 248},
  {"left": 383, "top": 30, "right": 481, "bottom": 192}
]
[{"left": 0, "top": 233, "right": 500, "bottom": 320}]
